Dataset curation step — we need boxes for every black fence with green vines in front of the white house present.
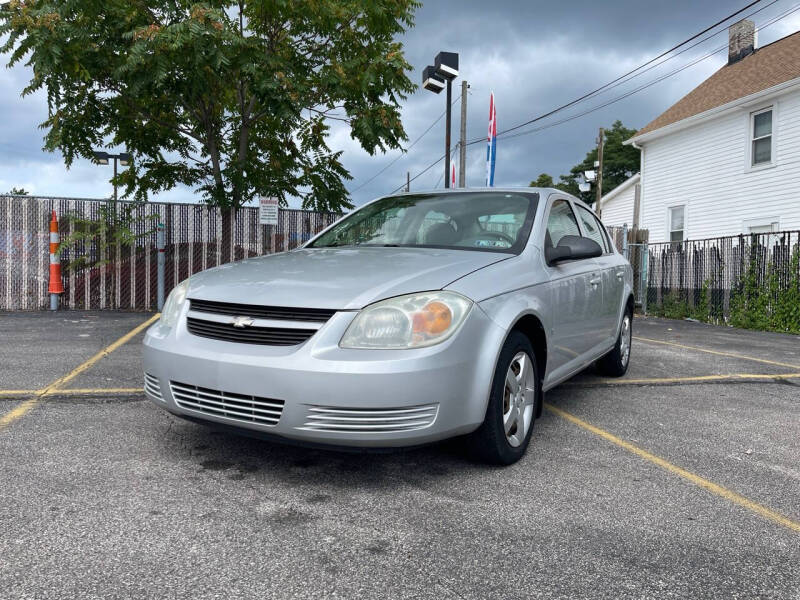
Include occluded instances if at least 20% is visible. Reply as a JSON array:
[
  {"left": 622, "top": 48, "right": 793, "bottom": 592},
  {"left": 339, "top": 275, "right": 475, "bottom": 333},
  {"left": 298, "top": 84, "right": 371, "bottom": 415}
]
[{"left": 644, "top": 231, "right": 800, "bottom": 332}]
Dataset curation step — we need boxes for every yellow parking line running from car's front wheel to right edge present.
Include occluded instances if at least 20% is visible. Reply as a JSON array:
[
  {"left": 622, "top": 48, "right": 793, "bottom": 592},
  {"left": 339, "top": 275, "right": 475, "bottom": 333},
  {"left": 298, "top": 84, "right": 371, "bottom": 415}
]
[{"left": 545, "top": 404, "right": 800, "bottom": 533}]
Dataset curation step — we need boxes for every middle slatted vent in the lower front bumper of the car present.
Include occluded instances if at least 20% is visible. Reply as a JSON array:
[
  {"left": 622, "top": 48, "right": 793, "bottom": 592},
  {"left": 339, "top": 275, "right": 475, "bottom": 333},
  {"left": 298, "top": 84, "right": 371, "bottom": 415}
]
[{"left": 170, "top": 381, "right": 283, "bottom": 425}]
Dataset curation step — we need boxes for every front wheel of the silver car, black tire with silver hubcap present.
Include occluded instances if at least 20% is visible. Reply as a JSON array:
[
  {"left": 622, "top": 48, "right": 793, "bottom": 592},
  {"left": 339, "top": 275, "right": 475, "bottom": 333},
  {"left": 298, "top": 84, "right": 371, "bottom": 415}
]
[{"left": 469, "top": 331, "right": 541, "bottom": 465}]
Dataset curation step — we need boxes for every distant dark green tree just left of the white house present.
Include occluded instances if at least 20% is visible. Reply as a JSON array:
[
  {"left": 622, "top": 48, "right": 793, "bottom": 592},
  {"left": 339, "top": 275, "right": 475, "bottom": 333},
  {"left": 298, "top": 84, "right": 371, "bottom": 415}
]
[{"left": 558, "top": 120, "right": 639, "bottom": 204}]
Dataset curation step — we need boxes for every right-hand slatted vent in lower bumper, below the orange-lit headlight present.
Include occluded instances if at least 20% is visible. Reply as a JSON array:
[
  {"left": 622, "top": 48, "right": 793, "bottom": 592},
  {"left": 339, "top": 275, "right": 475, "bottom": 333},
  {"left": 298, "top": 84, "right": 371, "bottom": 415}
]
[{"left": 301, "top": 404, "right": 439, "bottom": 433}]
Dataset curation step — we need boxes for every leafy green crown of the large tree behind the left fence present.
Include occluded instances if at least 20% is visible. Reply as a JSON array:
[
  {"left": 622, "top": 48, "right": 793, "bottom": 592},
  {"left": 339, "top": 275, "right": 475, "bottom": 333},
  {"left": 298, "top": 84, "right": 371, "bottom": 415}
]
[{"left": 0, "top": 0, "right": 418, "bottom": 211}]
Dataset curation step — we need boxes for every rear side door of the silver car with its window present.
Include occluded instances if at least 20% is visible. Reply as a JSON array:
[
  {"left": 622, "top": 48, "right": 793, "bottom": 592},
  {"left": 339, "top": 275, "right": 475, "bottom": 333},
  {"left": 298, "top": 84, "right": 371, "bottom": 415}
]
[{"left": 576, "top": 205, "right": 625, "bottom": 346}]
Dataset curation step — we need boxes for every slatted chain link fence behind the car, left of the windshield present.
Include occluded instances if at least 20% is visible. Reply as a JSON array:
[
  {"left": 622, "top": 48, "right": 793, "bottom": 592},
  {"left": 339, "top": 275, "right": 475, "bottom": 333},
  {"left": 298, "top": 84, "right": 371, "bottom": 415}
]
[{"left": 0, "top": 196, "right": 341, "bottom": 310}]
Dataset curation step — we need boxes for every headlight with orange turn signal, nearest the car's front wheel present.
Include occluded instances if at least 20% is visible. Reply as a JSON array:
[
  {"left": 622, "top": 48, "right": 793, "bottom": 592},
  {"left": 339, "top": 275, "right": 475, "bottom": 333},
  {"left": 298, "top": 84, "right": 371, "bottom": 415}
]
[{"left": 339, "top": 292, "right": 472, "bottom": 350}]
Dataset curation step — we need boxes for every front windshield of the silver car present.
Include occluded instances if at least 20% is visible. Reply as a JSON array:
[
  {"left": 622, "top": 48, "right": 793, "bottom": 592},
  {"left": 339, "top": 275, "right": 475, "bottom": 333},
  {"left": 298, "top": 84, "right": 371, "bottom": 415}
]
[{"left": 308, "top": 192, "right": 539, "bottom": 254}]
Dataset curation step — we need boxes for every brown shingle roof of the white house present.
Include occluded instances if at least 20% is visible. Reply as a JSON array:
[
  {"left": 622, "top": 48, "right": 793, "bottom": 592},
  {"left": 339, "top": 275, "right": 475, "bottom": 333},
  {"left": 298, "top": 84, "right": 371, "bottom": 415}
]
[{"left": 634, "top": 31, "right": 800, "bottom": 137}]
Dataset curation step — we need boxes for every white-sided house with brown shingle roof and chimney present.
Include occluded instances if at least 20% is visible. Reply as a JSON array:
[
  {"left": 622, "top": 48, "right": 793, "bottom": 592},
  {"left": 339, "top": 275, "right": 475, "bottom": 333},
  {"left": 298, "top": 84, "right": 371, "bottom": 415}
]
[{"left": 602, "top": 20, "right": 800, "bottom": 242}]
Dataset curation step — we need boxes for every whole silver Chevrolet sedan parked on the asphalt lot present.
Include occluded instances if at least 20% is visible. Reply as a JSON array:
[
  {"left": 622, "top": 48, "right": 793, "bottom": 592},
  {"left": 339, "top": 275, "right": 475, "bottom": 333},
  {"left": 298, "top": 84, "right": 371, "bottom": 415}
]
[{"left": 144, "top": 188, "right": 633, "bottom": 464}]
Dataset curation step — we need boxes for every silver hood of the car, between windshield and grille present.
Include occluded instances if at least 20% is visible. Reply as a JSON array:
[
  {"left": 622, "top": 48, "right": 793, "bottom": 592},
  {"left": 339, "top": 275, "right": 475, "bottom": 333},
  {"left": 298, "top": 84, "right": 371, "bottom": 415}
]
[{"left": 188, "top": 247, "right": 512, "bottom": 310}]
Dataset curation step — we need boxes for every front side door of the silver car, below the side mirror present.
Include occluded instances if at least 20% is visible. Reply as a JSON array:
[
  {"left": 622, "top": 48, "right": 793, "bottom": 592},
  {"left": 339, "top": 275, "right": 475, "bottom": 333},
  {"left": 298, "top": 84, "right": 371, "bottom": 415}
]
[{"left": 544, "top": 198, "right": 603, "bottom": 379}]
